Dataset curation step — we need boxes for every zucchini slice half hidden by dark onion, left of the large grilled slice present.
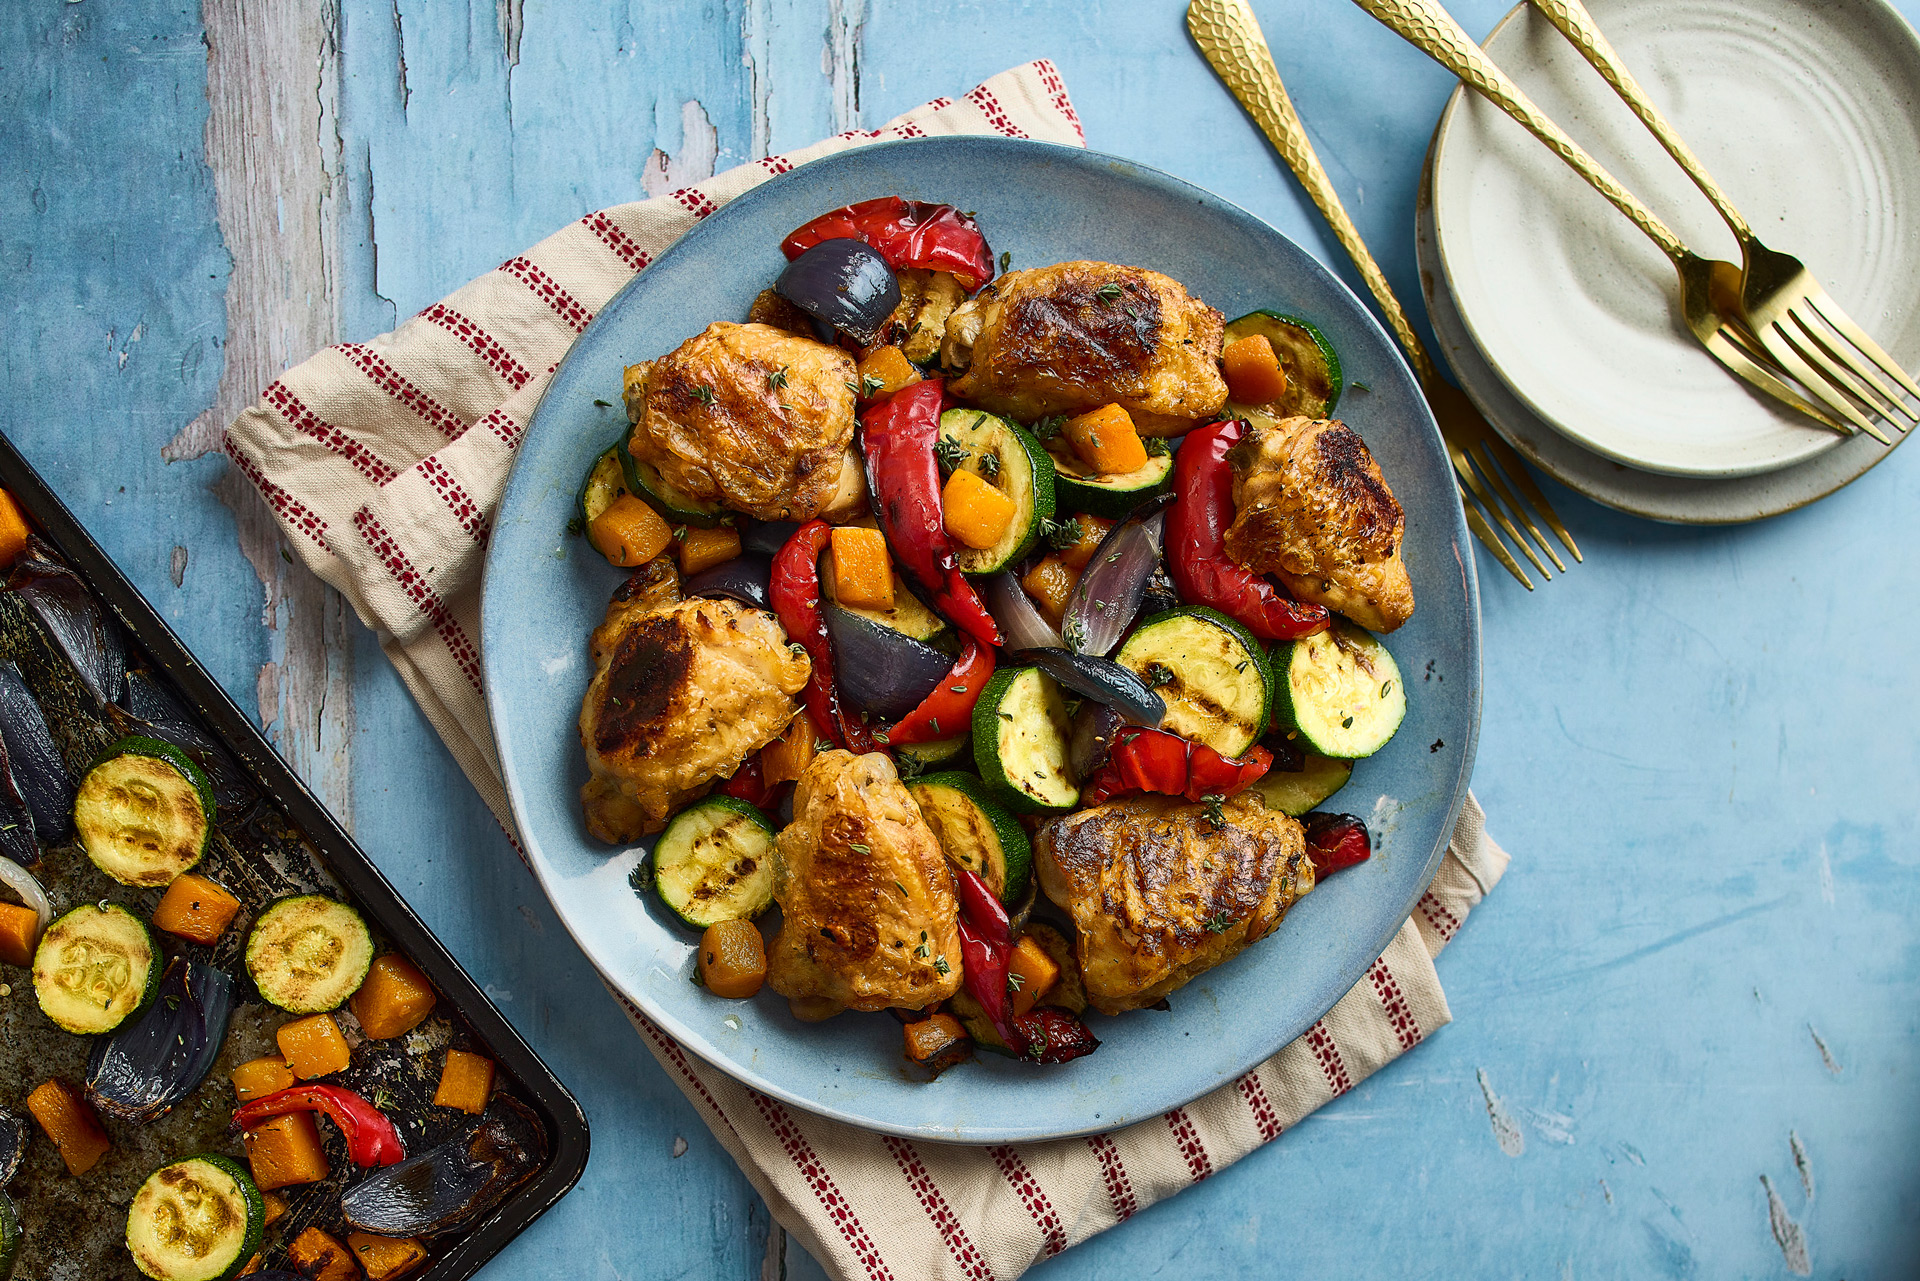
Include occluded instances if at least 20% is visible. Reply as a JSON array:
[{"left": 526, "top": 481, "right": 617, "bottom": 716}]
[{"left": 973, "top": 666, "right": 1079, "bottom": 814}]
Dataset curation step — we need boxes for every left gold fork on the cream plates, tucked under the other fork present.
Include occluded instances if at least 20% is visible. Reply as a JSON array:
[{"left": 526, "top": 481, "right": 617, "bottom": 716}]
[{"left": 1354, "top": 0, "right": 1866, "bottom": 444}]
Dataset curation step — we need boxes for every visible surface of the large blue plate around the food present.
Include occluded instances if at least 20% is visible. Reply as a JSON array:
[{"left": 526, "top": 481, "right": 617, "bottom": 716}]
[{"left": 482, "top": 138, "right": 1480, "bottom": 1143}]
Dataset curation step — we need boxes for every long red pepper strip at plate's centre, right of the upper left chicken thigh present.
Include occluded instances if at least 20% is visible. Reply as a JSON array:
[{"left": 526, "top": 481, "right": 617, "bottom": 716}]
[{"left": 860, "top": 378, "right": 1000, "bottom": 645}]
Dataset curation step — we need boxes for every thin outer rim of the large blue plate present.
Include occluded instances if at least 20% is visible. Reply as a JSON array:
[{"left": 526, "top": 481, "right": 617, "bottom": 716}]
[{"left": 480, "top": 134, "right": 1484, "bottom": 1147}]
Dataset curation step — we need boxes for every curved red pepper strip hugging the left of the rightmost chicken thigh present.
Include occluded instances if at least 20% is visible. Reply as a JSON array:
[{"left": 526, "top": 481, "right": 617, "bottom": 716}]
[{"left": 1167, "top": 419, "right": 1331, "bottom": 640}]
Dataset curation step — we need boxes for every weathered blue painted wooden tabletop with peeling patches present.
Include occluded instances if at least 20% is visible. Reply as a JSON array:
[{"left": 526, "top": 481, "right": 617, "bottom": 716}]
[{"left": 0, "top": 0, "right": 1920, "bottom": 1281}]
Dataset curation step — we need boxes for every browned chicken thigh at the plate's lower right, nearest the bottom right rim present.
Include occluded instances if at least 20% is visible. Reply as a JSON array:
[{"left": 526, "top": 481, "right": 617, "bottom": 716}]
[{"left": 1033, "top": 793, "right": 1313, "bottom": 1014}]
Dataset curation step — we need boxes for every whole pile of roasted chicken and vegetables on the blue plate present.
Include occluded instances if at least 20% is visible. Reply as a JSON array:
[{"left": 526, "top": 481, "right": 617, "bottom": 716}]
[{"left": 580, "top": 196, "right": 1413, "bottom": 1076}]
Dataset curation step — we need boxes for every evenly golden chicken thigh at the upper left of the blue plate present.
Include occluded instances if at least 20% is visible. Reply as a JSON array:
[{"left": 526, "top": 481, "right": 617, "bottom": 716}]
[{"left": 626, "top": 323, "right": 866, "bottom": 520}]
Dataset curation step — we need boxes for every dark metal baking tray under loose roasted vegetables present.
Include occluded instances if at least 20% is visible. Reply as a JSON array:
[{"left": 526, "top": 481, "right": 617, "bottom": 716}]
[{"left": 0, "top": 434, "right": 588, "bottom": 1281}]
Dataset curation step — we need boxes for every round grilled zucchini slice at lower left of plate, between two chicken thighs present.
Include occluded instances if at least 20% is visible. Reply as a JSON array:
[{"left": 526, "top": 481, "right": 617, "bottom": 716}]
[{"left": 653, "top": 797, "right": 774, "bottom": 930}]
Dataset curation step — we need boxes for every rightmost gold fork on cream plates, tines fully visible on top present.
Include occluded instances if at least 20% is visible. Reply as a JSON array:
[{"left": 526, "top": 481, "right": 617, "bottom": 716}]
[{"left": 1534, "top": 0, "right": 1920, "bottom": 440}]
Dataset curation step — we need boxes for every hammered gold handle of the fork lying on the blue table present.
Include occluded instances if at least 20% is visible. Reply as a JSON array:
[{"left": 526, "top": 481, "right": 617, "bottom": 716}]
[{"left": 1187, "top": 0, "right": 1434, "bottom": 384}]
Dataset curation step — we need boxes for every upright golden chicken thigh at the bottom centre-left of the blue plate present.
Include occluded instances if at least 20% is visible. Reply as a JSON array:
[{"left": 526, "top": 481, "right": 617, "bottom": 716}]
[{"left": 766, "top": 751, "right": 960, "bottom": 1020}]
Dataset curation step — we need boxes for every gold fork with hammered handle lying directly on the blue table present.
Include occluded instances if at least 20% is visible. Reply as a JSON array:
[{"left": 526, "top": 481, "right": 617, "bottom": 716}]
[{"left": 1187, "top": 0, "right": 1582, "bottom": 592}]
